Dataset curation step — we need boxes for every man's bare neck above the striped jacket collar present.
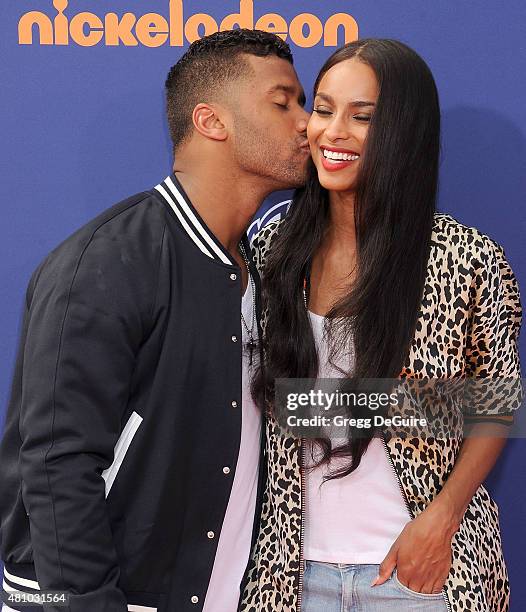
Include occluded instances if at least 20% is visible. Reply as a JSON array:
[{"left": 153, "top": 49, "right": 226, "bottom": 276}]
[{"left": 174, "top": 163, "right": 269, "bottom": 259}]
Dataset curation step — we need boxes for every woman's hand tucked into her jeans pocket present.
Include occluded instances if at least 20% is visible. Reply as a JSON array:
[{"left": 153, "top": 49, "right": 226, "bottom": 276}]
[{"left": 371, "top": 491, "right": 459, "bottom": 593}]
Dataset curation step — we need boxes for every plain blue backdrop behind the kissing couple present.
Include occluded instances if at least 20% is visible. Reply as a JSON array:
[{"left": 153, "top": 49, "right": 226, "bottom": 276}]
[{"left": 0, "top": 0, "right": 526, "bottom": 612}]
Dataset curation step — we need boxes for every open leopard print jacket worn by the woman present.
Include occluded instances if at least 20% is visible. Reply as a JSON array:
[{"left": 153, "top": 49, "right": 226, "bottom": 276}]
[{"left": 239, "top": 214, "right": 521, "bottom": 612}]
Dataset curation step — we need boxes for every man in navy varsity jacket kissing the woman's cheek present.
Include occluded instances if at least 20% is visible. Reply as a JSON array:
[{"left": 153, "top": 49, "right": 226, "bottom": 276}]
[{"left": 0, "top": 30, "right": 308, "bottom": 612}]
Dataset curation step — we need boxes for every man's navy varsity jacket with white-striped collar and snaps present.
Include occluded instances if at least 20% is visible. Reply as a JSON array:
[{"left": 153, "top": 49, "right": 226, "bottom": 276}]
[{"left": 0, "top": 175, "right": 264, "bottom": 612}]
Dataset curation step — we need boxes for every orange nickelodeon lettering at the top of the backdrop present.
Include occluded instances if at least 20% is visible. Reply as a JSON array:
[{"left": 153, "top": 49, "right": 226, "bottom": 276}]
[{"left": 18, "top": 0, "right": 358, "bottom": 47}]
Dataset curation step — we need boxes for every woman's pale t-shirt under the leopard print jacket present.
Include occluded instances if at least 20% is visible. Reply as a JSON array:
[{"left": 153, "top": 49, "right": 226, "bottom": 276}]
[{"left": 304, "top": 312, "right": 410, "bottom": 564}]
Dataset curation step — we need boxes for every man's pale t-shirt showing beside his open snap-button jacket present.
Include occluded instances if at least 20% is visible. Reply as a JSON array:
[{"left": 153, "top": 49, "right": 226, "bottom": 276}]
[{"left": 203, "top": 282, "right": 261, "bottom": 612}]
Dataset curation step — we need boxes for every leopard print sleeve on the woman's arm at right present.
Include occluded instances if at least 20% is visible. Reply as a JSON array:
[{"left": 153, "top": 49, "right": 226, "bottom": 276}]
[{"left": 464, "top": 237, "right": 522, "bottom": 419}]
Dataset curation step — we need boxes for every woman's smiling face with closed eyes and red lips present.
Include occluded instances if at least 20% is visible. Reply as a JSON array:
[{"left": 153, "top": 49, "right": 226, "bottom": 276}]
[{"left": 307, "top": 58, "right": 378, "bottom": 192}]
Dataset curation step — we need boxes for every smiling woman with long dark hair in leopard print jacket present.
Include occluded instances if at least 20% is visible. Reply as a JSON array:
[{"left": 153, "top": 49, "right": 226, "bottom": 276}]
[{"left": 241, "top": 39, "right": 520, "bottom": 612}]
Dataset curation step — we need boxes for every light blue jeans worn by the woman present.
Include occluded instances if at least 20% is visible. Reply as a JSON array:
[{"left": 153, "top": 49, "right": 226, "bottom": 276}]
[{"left": 301, "top": 561, "right": 447, "bottom": 612}]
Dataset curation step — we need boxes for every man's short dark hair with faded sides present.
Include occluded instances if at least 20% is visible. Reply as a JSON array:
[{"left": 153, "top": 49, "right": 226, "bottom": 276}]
[{"left": 166, "top": 28, "right": 293, "bottom": 150}]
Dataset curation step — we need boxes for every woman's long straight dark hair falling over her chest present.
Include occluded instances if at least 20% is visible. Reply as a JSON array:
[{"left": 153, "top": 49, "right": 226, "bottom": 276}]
[{"left": 253, "top": 39, "right": 440, "bottom": 478}]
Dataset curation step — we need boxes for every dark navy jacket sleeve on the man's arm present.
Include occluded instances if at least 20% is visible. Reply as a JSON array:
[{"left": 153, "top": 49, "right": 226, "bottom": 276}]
[{"left": 20, "top": 213, "right": 163, "bottom": 612}]
